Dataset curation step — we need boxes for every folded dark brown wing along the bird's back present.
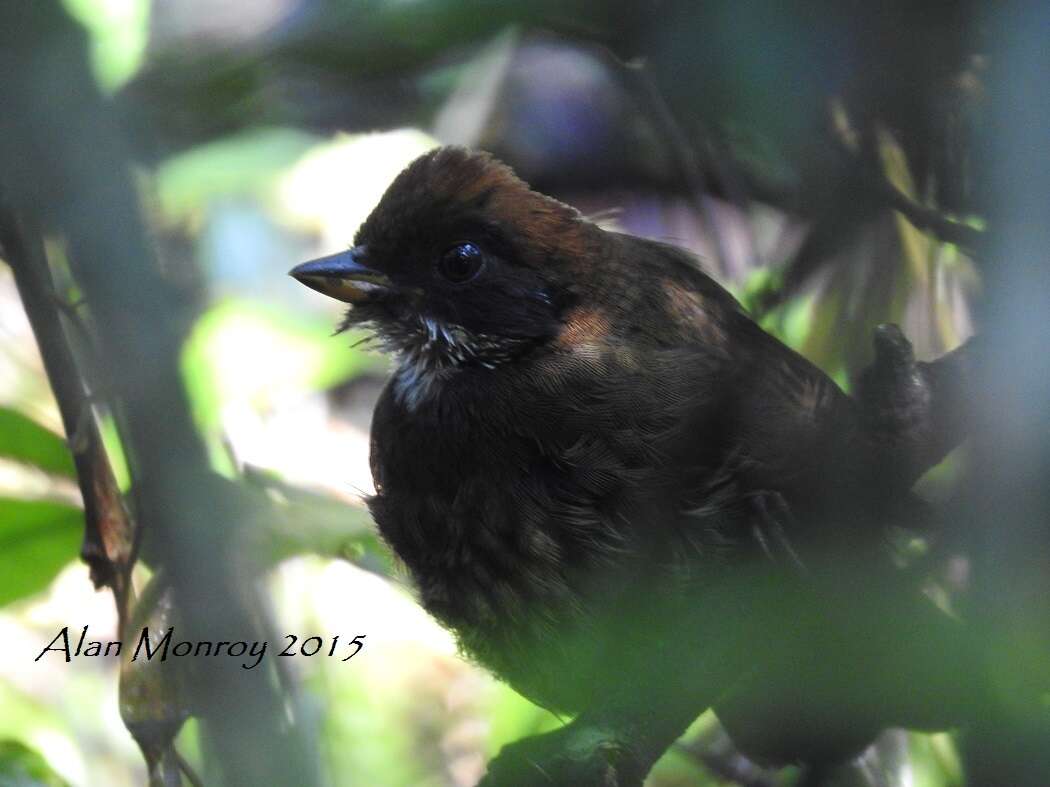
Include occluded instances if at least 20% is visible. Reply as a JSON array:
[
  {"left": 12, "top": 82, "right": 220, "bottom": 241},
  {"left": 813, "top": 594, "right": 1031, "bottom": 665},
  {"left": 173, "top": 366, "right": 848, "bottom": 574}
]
[{"left": 642, "top": 240, "right": 865, "bottom": 558}]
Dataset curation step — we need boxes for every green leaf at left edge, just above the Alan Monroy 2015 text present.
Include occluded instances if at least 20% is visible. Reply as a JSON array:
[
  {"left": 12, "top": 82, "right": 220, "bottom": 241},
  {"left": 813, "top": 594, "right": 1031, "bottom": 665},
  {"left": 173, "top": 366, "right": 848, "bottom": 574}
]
[{"left": 0, "top": 497, "right": 84, "bottom": 607}]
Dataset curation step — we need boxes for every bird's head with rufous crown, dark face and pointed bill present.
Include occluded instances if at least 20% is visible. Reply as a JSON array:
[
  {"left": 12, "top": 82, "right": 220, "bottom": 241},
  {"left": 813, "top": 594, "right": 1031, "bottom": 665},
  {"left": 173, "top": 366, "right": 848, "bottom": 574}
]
[{"left": 291, "top": 147, "right": 596, "bottom": 396}]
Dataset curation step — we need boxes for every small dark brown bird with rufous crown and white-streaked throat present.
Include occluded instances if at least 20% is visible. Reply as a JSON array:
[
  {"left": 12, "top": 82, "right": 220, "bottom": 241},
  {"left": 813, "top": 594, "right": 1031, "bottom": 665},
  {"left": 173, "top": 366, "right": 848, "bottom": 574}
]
[{"left": 292, "top": 148, "right": 974, "bottom": 784}]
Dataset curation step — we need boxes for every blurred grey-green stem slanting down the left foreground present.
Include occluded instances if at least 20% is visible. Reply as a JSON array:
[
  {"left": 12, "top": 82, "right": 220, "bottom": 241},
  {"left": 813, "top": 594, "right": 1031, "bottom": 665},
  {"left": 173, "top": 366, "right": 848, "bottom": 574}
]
[{"left": 0, "top": 0, "right": 318, "bottom": 785}]
